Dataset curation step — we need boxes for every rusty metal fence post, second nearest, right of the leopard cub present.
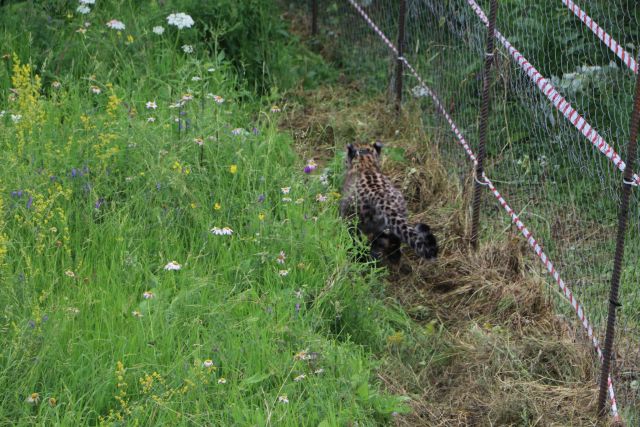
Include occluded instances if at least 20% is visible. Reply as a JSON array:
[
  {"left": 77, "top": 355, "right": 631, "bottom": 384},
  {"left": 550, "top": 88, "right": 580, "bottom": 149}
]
[{"left": 471, "top": 0, "right": 498, "bottom": 249}]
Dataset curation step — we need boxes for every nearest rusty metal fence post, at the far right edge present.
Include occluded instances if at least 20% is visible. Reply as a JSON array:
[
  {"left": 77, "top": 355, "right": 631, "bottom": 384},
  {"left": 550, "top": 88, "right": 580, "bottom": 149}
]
[{"left": 598, "top": 57, "right": 640, "bottom": 422}]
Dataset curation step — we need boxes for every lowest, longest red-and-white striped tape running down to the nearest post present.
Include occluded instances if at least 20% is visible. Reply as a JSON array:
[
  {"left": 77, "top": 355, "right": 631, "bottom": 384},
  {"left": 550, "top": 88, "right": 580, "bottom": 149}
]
[{"left": 347, "top": 0, "right": 620, "bottom": 420}]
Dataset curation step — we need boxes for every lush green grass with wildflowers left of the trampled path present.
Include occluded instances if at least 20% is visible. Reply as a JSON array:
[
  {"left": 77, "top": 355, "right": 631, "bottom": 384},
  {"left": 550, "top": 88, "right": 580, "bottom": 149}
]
[{"left": 0, "top": 2, "right": 416, "bottom": 426}]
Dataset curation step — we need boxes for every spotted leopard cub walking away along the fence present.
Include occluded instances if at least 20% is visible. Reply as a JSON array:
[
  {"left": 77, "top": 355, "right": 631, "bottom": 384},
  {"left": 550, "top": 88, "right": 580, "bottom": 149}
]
[{"left": 340, "top": 142, "right": 438, "bottom": 263}]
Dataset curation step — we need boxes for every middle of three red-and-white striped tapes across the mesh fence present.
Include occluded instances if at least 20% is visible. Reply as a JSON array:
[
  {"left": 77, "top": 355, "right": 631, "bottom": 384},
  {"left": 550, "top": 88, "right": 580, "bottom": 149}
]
[{"left": 467, "top": 0, "right": 640, "bottom": 189}]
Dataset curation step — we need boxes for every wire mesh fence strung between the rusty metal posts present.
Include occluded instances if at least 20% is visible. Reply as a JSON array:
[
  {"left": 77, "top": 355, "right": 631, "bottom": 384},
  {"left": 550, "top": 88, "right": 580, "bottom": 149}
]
[{"left": 290, "top": 0, "right": 640, "bottom": 422}]
